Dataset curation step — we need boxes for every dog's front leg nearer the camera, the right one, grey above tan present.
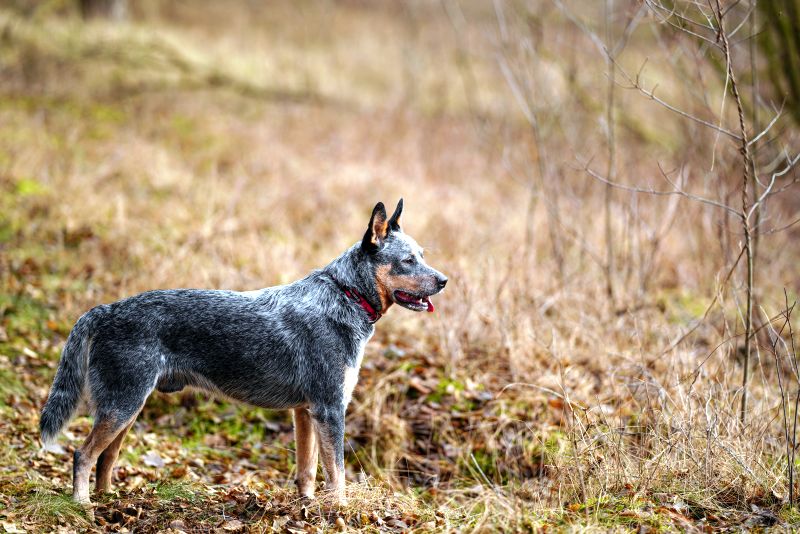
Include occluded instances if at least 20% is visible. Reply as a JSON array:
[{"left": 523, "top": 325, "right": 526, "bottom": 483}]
[{"left": 311, "top": 404, "right": 347, "bottom": 505}]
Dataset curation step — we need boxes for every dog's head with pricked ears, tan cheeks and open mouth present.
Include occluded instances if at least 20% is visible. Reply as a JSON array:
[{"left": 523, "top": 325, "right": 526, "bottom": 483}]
[{"left": 361, "top": 198, "right": 447, "bottom": 312}]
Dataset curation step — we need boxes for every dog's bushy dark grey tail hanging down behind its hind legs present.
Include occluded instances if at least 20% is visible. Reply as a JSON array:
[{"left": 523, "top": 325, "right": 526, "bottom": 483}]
[{"left": 39, "top": 306, "right": 102, "bottom": 445}]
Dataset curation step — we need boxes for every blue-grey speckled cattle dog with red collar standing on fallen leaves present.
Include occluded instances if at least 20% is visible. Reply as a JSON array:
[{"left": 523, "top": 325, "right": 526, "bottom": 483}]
[{"left": 39, "top": 199, "right": 447, "bottom": 504}]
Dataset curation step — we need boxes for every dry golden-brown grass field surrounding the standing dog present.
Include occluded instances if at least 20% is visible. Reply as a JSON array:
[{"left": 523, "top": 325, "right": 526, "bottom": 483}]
[{"left": 0, "top": 2, "right": 800, "bottom": 530}]
